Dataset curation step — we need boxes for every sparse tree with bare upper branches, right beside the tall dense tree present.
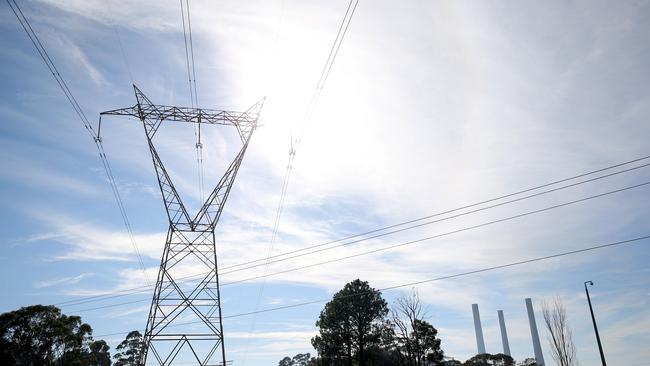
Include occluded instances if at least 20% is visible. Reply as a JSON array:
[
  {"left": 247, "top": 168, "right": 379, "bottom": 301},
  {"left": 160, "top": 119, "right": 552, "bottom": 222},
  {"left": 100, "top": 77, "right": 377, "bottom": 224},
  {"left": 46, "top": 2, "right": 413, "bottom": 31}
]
[{"left": 391, "top": 291, "right": 444, "bottom": 366}]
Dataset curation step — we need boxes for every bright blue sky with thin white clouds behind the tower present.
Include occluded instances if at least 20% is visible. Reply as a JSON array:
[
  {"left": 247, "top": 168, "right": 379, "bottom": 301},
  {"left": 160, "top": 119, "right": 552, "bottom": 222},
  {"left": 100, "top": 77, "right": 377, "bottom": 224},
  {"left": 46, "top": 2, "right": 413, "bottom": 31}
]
[{"left": 0, "top": 0, "right": 650, "bottom": 366}]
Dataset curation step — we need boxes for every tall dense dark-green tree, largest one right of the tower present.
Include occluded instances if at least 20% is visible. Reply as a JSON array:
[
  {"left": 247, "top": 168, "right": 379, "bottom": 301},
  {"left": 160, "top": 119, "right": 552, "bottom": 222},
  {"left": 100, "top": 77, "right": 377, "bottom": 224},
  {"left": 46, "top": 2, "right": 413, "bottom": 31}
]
[{"left": 312, "top": 279, "right": 388, "bottom": 366}]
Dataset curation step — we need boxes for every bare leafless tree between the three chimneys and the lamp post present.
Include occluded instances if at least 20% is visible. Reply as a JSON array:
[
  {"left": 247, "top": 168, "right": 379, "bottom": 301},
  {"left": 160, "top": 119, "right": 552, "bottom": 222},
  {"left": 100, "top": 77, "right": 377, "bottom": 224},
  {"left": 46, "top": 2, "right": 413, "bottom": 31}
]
[{"left": 542, "top": 297, "right": 578, "bottom": 366}]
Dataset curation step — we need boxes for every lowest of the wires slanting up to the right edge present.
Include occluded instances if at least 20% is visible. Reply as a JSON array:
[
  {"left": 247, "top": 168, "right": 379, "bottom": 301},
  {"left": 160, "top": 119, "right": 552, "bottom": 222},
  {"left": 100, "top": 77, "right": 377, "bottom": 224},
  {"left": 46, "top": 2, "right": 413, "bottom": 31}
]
[{"left": 86, "top": 235, "right": 650, "bottom": 338}]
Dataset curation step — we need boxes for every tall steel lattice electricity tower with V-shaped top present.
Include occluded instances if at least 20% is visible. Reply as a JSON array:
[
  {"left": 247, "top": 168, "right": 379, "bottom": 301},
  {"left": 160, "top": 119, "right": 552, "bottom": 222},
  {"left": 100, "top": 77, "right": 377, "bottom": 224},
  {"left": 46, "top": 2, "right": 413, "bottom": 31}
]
[{"left": 100, "top": 85, "right": 264, "bottom": 366}]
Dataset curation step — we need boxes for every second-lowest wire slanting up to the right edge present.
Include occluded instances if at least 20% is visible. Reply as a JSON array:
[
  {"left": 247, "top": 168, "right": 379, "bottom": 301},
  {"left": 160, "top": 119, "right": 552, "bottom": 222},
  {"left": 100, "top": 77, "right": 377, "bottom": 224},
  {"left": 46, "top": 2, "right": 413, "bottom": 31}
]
[{"left": 55, "top": 177, "right": 650, "bottom": 306}]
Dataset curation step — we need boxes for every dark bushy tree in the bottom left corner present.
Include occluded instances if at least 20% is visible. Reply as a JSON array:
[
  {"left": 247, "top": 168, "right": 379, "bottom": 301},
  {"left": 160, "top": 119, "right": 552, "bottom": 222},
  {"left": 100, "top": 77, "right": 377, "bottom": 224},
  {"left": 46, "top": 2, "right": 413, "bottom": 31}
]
[{"left": 0, "top": 305, "right": 92, "bottom": 366}]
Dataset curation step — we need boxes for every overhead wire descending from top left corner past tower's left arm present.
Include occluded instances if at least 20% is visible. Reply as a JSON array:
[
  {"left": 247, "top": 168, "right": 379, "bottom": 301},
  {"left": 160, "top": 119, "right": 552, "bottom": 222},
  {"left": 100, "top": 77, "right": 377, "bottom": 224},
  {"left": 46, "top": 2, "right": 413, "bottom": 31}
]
[{"left": 6, "top": 0, "right": 150, "bottom": 282}]
